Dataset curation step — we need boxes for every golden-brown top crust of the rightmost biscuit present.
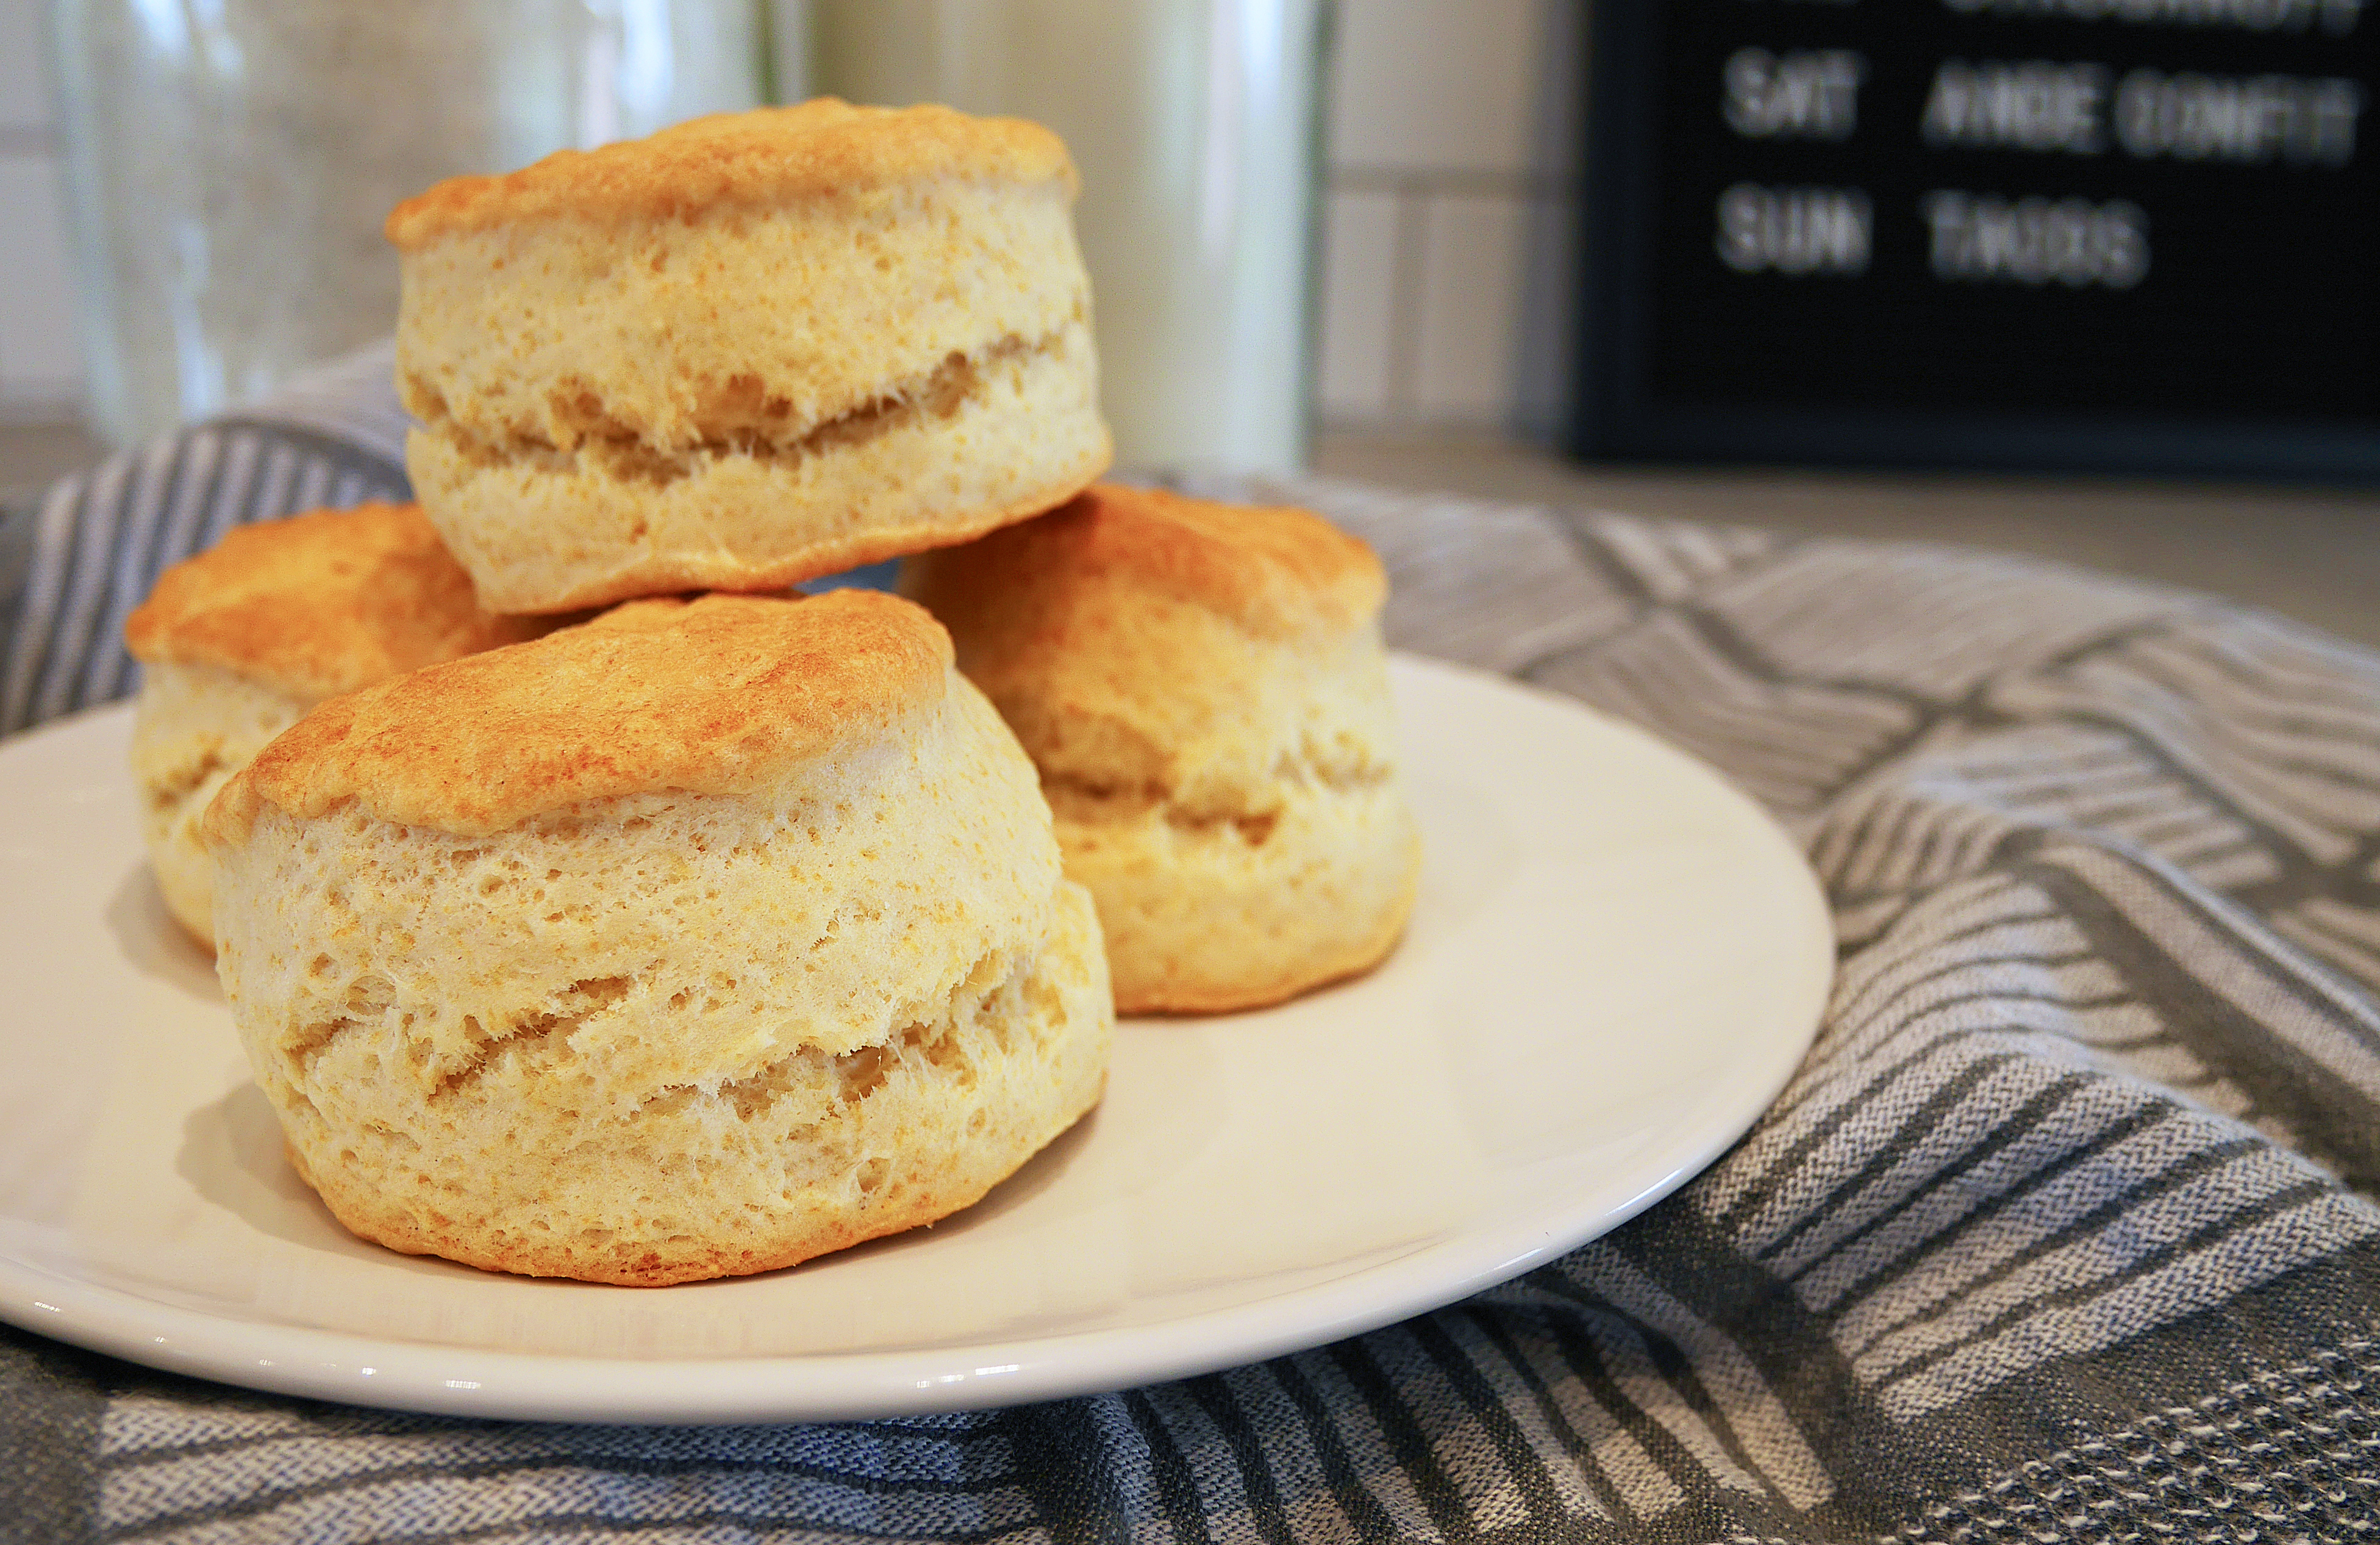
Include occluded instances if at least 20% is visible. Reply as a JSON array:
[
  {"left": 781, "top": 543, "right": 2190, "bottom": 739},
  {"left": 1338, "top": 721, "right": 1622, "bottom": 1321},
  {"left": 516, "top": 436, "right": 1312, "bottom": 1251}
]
[{"left": 921, "top": 483, "right": 1387, "bottom": 638}]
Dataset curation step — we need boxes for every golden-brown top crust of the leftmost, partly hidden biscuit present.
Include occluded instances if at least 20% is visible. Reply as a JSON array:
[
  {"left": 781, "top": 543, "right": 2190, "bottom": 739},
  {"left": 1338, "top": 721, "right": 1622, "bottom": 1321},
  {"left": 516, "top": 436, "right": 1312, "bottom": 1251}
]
[{"left": 124, "top": 504, "right": 554, "bottom": 702}]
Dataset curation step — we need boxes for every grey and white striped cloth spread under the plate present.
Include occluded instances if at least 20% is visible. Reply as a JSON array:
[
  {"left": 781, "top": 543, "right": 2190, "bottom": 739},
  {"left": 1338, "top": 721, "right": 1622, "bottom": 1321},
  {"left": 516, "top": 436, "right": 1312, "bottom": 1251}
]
[{"left": 0, "top": 355, "right": 2380, "bottom": 1545}]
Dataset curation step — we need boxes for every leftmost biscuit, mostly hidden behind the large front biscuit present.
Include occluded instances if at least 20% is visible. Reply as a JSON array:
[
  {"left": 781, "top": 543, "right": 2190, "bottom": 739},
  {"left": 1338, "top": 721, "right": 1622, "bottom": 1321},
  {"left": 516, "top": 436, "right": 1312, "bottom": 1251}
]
[{"left": 124, "top": 504, "right": 552, "bottom": 947}]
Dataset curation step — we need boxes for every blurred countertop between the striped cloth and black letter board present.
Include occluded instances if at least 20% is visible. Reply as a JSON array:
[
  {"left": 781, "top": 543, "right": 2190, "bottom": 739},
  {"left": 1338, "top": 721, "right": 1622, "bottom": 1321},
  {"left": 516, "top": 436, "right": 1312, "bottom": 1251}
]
[{"left": 0, "top": 424, "right": 2380, "bottom": 648}]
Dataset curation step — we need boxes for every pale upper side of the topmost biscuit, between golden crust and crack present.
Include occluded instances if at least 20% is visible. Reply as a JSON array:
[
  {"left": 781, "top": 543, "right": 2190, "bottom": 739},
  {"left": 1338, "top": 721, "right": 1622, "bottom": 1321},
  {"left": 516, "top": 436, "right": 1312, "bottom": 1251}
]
[{"left": 398, "top": 179, "right": 1090, "bottom": 478}]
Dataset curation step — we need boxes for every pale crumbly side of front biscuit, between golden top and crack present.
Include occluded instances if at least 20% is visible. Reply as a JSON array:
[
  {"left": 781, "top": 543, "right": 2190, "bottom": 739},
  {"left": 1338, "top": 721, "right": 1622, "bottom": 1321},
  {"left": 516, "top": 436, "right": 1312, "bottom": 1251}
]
[{"left": 224, "top": 683, "right": 1057, "bottom": 1090}]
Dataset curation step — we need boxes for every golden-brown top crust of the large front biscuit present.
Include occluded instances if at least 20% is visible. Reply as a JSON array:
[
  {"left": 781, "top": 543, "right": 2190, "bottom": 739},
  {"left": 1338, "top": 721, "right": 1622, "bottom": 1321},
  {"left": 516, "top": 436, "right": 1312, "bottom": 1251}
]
[{"left": 205, "top": 590, "right": 949, "bottom": 845}]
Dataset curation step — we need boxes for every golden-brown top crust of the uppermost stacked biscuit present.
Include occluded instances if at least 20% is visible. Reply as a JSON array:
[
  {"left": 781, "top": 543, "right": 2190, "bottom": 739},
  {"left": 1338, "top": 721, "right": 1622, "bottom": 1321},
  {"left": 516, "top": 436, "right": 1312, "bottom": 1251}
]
[{"left": 385, "top": 98, "right": 1076, "bottom": 250}]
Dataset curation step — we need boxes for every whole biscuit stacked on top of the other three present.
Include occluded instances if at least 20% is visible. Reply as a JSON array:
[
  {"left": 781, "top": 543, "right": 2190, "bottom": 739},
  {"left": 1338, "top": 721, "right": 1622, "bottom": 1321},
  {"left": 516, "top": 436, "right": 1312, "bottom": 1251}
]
[{"left": 388, "top": 98, "right": 1112, "bottom": 612}]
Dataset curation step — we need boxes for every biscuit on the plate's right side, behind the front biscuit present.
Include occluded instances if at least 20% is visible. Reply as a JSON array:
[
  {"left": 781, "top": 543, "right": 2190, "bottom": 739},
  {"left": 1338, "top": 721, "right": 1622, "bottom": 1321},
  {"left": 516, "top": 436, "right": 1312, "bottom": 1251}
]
[{"left": 902, "top": 486, "right": 1421, "bottom": 1014}]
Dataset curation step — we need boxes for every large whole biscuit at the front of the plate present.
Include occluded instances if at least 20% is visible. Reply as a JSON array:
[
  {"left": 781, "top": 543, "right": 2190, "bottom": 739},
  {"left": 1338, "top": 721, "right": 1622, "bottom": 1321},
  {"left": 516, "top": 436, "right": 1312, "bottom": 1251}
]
[{"left": 205, "top": 590, "right": 1114, "bottom": 1286}]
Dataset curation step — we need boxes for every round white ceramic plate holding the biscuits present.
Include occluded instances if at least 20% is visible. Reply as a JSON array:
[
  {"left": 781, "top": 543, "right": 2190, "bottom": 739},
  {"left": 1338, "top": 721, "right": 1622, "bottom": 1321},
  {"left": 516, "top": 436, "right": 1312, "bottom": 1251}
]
[{"left": 0, "top": 659, "right": 1832, "bottom": 1421}]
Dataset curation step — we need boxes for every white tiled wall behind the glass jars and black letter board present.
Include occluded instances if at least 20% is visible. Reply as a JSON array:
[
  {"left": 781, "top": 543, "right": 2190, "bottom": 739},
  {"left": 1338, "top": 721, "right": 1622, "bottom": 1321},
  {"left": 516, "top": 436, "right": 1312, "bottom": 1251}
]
[{"left": 0, "top": 0, "right": 1581, "bottom": 440}]
